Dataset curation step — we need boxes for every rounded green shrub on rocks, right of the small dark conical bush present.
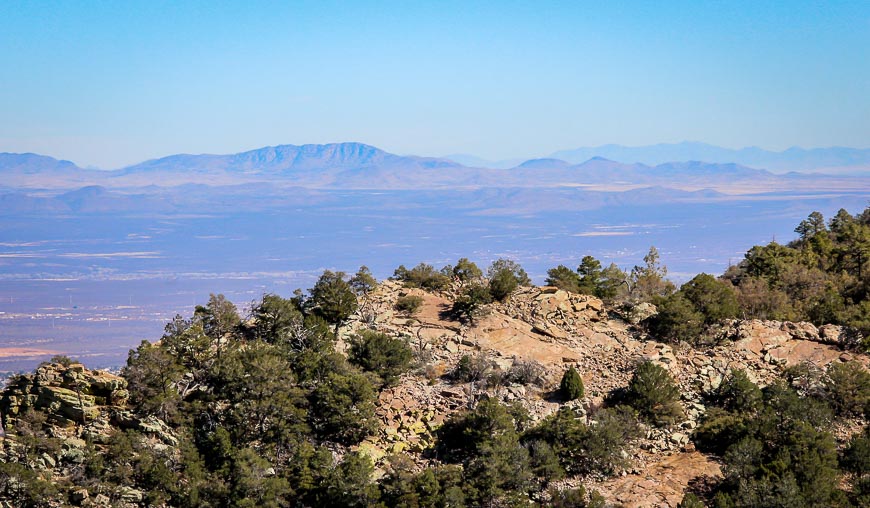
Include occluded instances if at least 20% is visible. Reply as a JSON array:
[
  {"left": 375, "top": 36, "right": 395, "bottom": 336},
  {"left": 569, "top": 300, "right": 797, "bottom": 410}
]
[{"left": 628, "top": 361, "right": 684, "bottom": 426}]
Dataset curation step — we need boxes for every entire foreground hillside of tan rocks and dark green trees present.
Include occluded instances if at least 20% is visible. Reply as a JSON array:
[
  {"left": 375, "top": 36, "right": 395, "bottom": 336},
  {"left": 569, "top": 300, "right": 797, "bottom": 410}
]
[{"left": 0, "top": 207, "right": 870, "bottom": 507}]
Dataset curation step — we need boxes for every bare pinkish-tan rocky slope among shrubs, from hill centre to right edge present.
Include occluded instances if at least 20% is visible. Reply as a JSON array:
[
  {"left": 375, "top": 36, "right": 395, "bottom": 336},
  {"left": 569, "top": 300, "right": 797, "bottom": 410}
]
[{"left": 342, "top": 281, "right": 868, "bottom": 507}]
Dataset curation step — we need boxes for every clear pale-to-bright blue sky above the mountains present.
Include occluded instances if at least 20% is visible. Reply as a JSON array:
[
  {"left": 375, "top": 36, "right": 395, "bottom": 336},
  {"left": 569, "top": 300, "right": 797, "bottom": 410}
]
[{"left": 0, "top": 0, "right": 870, "bottom": 168}]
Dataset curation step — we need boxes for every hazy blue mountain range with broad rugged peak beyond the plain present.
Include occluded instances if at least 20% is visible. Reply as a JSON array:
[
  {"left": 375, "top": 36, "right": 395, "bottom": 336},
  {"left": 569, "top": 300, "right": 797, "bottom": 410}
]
[{"left": 0, "top": 143, "right": 861, "bottom": 192}]
